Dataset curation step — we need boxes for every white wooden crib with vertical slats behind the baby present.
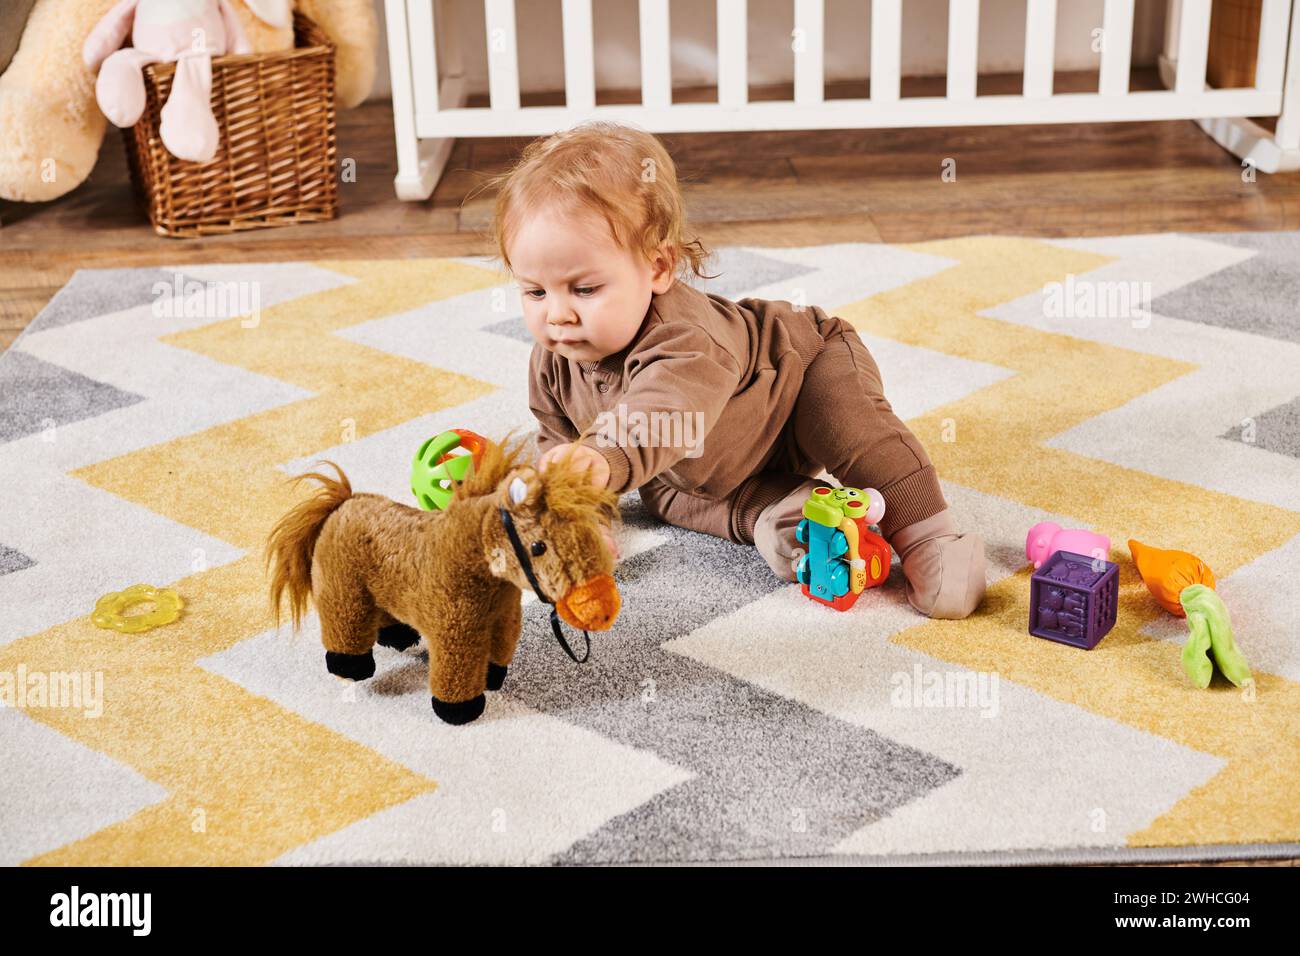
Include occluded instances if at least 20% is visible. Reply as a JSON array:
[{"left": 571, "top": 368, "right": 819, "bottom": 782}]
[{"left": 386, "top": 0, "right": 1300, "bottom": 200}]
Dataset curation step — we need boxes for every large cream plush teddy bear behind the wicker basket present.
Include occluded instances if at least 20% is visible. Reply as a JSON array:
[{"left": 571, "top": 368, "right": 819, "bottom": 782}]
[{"left": 0, "top": 0, "right": 378, "bottom": 202}]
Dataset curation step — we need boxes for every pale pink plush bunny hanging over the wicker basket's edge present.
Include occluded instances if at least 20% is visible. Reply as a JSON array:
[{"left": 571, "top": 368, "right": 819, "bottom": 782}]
[{"left": 82, "top": 0, "right": 290, "bottom": 163}]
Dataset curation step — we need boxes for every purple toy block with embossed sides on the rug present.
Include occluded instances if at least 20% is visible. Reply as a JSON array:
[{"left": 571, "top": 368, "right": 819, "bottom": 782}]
[{"left": 1030, "top": 551, "right": 1119, "bottom": 650}]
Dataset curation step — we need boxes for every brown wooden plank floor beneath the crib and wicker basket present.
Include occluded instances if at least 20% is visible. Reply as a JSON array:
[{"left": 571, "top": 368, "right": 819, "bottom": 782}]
[{"left": 0, "top": 70, "right": 1300, "bottom": 866}]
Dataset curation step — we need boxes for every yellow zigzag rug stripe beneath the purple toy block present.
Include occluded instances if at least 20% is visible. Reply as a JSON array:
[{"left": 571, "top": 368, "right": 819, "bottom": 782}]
[{"left": 839, "top": 237, "right": 1300, "bottom": 845}]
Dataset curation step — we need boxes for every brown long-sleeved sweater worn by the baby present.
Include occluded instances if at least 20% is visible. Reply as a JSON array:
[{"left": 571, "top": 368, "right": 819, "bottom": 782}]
[{"left": 528, "top": 280, "right": 828, "bottom": 498}]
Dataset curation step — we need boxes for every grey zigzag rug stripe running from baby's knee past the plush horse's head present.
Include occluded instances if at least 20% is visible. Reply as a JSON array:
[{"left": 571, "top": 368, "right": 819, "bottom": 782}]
[{"left": 502, "top": 494, "right": 959, "bottom": 864}]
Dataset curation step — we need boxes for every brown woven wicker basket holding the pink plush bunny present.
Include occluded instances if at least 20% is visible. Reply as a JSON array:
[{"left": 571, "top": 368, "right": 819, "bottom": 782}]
[{"left": 122, "top": 14, "right": 338, "bottom": 238}]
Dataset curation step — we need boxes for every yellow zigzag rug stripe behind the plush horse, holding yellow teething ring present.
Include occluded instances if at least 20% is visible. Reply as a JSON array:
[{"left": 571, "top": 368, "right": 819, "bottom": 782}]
[{"left": 0, "top": 260, "right": 501, "bottom": 865}]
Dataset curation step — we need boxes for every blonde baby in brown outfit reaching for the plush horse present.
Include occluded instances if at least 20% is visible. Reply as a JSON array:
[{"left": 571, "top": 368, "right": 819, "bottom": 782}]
[{"left": 491, "top": 122, "right": 985, "bottom": 618}]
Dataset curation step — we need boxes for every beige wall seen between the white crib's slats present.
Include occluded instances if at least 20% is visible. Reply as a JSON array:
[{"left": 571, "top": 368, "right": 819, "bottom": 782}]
[{"left": 374, "top": 0, "right": 1165, "bottom": 98}]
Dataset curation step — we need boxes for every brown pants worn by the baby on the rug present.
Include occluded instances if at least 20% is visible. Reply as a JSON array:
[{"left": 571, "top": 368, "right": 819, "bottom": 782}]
[{"left": 641, "top": 319, "right": 948, "bottom": 580}]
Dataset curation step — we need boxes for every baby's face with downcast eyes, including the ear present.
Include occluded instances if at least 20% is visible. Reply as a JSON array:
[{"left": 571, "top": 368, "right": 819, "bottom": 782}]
[{"left": 508, "top": 208, "right": 672, "bottom": 362}]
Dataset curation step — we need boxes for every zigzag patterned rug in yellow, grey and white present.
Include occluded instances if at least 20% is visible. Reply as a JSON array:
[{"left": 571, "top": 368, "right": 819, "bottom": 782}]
[{"left": 0, "top": 233, "right": 1300, "bottom": 865}]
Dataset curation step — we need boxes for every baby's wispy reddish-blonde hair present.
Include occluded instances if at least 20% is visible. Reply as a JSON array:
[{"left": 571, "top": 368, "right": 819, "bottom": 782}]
[{"left": 473, "top": 121, "right": 716, "bottom": 278}]
